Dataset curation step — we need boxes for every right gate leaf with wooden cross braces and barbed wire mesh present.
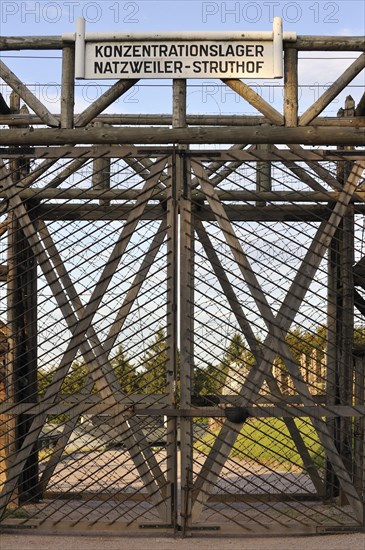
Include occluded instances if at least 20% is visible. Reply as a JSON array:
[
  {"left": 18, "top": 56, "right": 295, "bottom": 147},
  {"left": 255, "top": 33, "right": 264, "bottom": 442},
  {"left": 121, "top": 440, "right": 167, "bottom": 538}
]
[{"left": 184, "top": 160, "right": 364, "bottom": 533}]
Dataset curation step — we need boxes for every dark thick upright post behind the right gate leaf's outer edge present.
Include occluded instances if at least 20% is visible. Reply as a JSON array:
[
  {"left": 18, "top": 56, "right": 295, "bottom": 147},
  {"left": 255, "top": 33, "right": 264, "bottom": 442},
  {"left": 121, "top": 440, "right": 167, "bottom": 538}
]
[{"left": 326, "top": 96, "right": 355, "bottom": 503}]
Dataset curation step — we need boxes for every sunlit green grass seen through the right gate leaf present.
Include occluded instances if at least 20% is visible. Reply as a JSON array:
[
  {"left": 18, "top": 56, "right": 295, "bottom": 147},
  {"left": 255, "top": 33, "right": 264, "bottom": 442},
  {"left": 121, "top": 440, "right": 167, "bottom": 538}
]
[{"left": 195, "top": 418, "right": 323, "bottom": 470}]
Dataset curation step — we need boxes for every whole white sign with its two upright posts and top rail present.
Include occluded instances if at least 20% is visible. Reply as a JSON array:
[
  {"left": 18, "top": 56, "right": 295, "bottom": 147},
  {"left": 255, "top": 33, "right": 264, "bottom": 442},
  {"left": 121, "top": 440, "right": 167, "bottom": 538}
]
[{"left": 63, "top": 17, "right": 296, "bottom": 80}]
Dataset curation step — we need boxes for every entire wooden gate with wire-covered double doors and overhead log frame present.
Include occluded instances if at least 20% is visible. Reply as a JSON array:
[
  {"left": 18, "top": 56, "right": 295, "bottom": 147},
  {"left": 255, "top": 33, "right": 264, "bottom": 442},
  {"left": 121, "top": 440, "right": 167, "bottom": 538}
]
[{"left": 0, "top": 30, "right": 365, "bottom": 535}]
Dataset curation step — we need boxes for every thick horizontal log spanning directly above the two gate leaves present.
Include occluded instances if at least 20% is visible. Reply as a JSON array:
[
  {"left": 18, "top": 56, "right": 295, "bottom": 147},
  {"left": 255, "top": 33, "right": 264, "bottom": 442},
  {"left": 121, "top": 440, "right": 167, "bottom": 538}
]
[{"left": 0, "top": 126, "right": 364, "bottom": 146}]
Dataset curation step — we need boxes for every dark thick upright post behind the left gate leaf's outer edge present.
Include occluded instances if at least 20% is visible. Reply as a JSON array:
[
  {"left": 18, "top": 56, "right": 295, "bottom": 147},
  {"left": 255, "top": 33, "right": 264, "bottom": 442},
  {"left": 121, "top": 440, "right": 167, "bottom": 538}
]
[{"left": 8, "top": 93, "right": 39, "bottom": 504}]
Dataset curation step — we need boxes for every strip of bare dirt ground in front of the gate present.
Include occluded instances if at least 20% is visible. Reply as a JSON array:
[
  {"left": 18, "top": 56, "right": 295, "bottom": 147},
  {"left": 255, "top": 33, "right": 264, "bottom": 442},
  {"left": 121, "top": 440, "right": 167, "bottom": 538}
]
[{"left": 0, "top": 533, "right": 365, "bottom": 550}]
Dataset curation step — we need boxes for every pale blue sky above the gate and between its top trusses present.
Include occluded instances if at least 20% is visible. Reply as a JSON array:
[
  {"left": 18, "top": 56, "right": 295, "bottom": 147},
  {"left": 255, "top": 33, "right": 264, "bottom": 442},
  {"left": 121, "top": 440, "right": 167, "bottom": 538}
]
[{"left": 0, "top": 0, "right": 365, "bottom": 116}]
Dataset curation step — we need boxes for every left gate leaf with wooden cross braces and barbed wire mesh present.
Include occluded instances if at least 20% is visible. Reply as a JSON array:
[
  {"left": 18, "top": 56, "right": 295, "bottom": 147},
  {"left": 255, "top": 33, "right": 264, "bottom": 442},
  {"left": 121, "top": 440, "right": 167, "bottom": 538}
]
[{"left": 1, "top": 153, "right": 175, "bottom": 527}]
